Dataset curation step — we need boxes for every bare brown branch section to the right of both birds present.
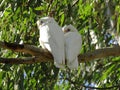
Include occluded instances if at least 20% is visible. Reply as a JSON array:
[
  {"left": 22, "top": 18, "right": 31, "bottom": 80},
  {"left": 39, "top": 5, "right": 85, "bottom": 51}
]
[{"left": 79, "top": 47, "right": 120, "bottom": 62}]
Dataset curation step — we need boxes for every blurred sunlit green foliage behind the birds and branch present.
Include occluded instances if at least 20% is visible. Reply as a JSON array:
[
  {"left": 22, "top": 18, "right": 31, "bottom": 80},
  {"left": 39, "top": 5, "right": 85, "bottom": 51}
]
[{"left": 0, "top": 0, "right": 120, "bottom": 90}]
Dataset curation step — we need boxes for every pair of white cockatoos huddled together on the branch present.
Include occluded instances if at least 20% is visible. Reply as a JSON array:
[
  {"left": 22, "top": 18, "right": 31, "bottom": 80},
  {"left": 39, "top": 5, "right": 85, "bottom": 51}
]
[{"left": 37, "top": 17, "right": 82, "bottom": 69}]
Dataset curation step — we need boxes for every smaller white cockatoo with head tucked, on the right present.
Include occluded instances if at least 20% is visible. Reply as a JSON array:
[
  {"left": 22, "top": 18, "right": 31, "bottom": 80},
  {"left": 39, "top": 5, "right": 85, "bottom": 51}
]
[{"left": 62, "top": 24, "right": 82, "bottom": 69}]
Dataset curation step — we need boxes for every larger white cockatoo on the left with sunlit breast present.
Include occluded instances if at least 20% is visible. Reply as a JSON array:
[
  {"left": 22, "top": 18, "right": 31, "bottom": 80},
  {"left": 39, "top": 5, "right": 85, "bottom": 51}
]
[{"left": 37, "top": 17, "right": 65, "bottom": 68}]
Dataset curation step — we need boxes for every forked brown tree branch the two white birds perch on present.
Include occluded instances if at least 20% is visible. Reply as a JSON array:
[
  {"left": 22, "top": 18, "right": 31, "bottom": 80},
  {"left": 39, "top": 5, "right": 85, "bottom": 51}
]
[{"left": 0, "top": 41, "right": 120, "bottom": 64}]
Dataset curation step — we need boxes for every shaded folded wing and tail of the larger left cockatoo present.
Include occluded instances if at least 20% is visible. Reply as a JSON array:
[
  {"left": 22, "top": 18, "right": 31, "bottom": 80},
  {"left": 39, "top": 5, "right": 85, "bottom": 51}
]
[{"left": 50, "top": 24, "right": 65, "bottom": 68}]
